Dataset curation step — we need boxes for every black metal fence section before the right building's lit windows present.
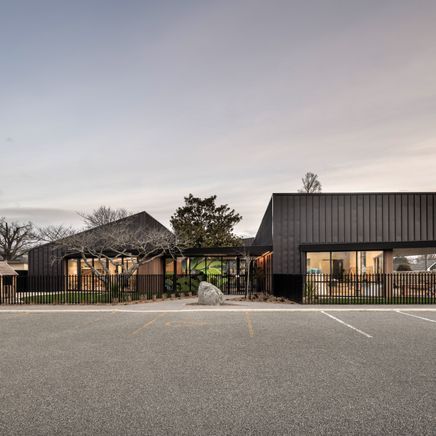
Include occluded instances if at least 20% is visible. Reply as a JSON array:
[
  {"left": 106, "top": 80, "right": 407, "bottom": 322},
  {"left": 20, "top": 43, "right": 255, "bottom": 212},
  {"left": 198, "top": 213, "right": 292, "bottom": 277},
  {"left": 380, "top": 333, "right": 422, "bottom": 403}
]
[{"left": 303, "top": 272, "right": 436, "bottom": 304}]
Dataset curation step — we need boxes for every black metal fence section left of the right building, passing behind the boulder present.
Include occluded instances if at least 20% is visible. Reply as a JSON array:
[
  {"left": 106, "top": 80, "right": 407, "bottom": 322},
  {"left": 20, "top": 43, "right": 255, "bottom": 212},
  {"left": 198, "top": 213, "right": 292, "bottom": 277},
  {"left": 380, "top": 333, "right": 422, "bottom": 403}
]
[{"left": 0, "top": 274, "right": 263, "bottom": 304}]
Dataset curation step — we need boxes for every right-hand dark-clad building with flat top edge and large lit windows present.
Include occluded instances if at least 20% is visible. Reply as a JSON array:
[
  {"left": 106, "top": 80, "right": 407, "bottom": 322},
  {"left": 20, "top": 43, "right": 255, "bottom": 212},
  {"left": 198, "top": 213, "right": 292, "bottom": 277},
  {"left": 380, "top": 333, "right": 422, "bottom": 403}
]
[{"left": 254, "top": 193, "right": 436, "bottom": 294}]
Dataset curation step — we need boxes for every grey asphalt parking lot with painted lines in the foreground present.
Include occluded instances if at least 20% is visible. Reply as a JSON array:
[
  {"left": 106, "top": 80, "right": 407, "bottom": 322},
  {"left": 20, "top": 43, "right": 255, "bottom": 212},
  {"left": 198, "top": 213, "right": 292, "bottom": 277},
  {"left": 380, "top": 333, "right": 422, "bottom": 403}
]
[{"left": 0, "top": 308, "right": 436, "bottom": 435}]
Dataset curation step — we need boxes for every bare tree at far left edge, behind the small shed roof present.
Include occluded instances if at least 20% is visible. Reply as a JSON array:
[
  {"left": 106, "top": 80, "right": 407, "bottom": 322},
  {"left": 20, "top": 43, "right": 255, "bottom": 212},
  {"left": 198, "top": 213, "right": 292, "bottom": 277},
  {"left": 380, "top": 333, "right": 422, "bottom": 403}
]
[{"left": 0, "top": 218, "right": 38, "bottom": 260}]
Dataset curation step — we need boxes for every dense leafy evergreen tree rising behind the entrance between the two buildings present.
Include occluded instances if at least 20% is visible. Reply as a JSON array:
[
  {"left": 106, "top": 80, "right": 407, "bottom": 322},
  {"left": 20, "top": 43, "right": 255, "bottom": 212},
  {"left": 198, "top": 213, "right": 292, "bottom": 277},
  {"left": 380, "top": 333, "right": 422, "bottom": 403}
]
[{"left": 170, "top": 194, "right": 242, "bottom": 248}]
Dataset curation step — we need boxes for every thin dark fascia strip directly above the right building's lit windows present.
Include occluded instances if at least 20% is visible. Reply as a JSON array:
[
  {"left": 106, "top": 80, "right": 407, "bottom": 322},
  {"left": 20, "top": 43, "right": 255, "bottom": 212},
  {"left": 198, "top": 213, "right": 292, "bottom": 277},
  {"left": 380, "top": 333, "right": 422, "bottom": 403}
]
[{"left": 300, "top": 241, "right": 436, "bottom": 252}]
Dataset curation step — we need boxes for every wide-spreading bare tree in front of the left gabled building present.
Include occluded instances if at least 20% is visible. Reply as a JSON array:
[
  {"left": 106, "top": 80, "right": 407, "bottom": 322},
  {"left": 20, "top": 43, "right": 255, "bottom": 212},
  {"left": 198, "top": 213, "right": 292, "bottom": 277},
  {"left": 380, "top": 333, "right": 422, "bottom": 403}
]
[{"left": 52, "top": 218, "right": 181, "bottom": 283}]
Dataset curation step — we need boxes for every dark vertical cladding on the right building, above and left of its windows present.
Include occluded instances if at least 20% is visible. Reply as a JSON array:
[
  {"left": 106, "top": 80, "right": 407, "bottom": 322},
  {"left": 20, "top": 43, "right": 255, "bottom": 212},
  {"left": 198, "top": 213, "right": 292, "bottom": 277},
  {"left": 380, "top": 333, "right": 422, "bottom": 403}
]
[{"left": 272, "top": 193, "right": 436, "bottom": 274}]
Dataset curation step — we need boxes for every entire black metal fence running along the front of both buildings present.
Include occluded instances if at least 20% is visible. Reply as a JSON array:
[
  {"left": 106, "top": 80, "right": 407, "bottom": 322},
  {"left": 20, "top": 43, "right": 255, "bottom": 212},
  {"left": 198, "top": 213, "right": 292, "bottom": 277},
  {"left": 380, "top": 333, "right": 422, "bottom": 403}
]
[{"left": 0, "top": 272, "right": 436, "bottom": 304}]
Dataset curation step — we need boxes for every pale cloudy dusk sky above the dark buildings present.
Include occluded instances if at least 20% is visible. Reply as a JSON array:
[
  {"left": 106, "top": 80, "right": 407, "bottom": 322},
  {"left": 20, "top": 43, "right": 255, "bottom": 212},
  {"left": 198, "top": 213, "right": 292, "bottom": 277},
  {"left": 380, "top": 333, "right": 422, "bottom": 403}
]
[{"left": 0, "top": 0, "right": 436, "bottom": 236}]
